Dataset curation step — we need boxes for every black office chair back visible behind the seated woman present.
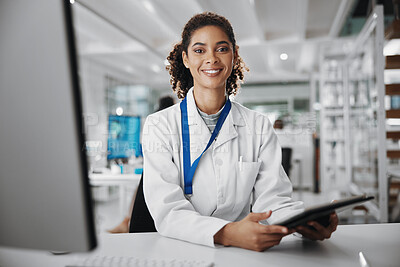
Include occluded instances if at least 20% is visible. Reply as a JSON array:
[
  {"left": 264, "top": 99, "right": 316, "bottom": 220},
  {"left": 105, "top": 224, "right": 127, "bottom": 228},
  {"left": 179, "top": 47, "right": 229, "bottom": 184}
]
[{"left": 129, "top": 173, "right": 157, "bottom": 233}]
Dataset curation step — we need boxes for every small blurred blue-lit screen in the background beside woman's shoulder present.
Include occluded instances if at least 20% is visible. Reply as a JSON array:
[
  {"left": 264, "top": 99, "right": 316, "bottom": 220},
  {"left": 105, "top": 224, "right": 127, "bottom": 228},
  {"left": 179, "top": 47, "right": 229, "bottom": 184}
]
[{"left": 107, "top": 115, "right": 142, "bottom": 160}]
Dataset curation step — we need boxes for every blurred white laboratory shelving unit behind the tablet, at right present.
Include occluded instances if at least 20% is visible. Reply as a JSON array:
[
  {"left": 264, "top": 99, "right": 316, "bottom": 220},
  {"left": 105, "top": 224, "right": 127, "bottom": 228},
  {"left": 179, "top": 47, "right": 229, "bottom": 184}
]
[{"left": 319, "top": 6, "right": 388, "bottom": 222}]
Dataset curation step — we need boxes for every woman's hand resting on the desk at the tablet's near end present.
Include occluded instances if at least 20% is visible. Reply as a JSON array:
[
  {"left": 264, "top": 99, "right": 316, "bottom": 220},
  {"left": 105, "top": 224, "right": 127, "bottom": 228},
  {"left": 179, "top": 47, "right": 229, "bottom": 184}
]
[{"left": 214, "top": 211, "right": 294, "bottom": 251}]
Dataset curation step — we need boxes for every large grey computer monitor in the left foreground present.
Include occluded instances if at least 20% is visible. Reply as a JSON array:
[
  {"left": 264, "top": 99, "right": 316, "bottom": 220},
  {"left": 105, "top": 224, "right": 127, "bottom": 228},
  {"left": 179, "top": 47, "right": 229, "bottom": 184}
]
[{"left": 0, "top": 0, "right": 96, "bottom": 252}]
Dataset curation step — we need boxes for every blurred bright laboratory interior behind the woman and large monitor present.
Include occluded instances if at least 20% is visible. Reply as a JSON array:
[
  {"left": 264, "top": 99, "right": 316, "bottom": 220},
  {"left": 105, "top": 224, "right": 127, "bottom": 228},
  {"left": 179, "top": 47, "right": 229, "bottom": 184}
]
[{"left": 71, "top": 0, "right": 400, "bottom": 231}]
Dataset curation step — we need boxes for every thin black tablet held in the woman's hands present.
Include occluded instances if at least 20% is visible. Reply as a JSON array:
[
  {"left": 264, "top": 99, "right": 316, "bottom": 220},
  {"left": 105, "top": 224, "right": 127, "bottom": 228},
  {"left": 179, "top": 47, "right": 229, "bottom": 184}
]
[{"left": 275, "top": 195, "right": 374, "bottom": 228}]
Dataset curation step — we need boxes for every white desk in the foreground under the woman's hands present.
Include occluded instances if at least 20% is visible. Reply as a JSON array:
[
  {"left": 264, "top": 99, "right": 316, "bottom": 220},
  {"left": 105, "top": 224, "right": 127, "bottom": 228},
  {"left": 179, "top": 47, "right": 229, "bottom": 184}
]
[{"left": 0, "top": 223, "right": 400, "bottom": 267}]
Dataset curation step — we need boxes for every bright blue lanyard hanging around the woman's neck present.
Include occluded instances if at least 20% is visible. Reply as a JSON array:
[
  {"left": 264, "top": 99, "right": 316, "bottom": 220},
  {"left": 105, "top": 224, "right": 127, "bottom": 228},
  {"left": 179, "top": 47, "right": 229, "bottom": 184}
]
[{"left": 180, "top": 97, "right": 231, "bottom": 195}]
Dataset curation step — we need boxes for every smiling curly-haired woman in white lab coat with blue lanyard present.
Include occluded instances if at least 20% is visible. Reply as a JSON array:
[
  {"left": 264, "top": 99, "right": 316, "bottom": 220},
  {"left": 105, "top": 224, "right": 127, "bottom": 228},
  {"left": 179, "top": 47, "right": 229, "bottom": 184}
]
[{"left": 143, "top": 12, "right": 338, "bottom": 251}]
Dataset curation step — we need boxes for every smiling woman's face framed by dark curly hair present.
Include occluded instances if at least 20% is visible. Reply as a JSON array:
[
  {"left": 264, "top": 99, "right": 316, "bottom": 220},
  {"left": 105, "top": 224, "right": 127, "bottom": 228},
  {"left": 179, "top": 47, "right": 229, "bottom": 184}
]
[{"left": 182, "top": 26, "right": 236, "bottom": 94}]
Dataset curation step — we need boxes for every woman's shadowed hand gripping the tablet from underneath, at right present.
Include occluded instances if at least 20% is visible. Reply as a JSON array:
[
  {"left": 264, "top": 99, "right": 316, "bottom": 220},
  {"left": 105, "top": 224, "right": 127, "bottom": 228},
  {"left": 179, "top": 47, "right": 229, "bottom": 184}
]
[{"left": 295, "top": 212, "right": 339, "bottom": 241}]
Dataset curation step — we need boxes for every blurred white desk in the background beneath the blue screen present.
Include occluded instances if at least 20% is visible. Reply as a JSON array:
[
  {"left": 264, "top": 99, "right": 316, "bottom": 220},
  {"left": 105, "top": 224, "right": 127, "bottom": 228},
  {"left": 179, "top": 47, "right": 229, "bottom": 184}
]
[{"left": 89, "top": 173, "right": 141, "bottom": 216}]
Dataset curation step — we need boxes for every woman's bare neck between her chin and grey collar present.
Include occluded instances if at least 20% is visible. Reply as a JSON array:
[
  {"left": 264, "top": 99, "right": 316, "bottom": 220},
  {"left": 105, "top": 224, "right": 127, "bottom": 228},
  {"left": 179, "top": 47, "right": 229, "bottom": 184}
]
[{"left": 193, "top": 88, "right": 226, "bottom": 115}]
